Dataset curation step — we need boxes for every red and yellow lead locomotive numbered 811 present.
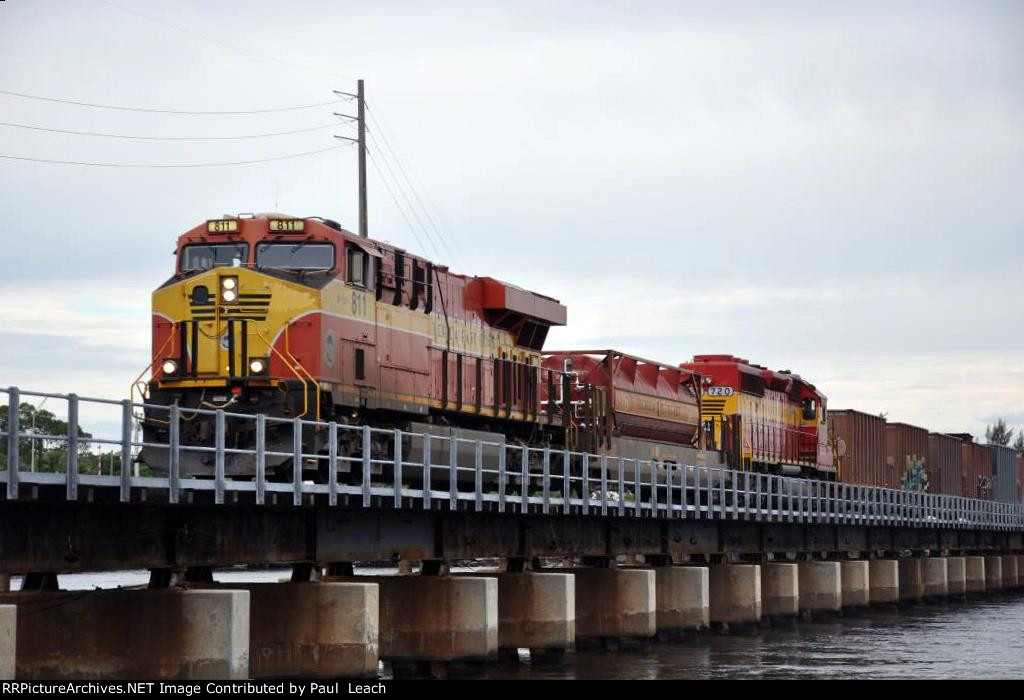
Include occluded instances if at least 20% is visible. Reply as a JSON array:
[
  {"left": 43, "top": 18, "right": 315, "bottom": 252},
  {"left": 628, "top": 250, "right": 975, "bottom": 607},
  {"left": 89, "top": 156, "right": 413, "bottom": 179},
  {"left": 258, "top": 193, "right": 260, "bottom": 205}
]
[{"left": 142, "top": 214, "right": 566, "bottom": 476}]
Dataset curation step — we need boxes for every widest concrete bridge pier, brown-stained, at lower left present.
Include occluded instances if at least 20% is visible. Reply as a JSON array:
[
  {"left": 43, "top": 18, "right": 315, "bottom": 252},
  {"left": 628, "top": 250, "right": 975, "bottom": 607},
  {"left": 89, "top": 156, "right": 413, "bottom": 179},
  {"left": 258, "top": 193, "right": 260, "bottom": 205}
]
[{"left": 0, "top": 590, "right": 249, "bottom": 681}]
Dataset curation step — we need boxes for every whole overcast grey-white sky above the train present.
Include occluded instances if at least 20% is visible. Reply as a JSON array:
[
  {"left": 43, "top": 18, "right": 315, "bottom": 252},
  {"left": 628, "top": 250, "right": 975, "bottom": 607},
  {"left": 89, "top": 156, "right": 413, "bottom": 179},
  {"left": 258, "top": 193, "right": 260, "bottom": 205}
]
[{"left": 0, "top": 0, "right": 1024, "bottom": 434}]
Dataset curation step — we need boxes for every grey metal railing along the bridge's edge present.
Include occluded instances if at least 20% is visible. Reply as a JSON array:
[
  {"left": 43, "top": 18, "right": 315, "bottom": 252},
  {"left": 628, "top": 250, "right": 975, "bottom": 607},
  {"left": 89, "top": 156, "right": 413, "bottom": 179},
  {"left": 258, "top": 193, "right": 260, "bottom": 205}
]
[{"left": 0, "top": 387, "right": 1024, "bottom": 531}]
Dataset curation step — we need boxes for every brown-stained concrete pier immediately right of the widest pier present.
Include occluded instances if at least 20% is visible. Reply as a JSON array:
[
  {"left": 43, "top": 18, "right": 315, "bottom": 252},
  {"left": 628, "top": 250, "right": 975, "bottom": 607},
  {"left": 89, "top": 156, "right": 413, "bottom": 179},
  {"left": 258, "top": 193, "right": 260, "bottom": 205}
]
[{"left": 206, "top": 582, "right": 379, "bottom": 679}]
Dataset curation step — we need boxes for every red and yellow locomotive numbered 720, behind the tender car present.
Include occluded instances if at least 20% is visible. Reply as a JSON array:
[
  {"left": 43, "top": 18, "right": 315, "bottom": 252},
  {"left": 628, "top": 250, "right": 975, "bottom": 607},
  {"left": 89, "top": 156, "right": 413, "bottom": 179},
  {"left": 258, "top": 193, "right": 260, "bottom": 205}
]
[{"left": 679, "top": 355, "right": 836, "bottom": 480}]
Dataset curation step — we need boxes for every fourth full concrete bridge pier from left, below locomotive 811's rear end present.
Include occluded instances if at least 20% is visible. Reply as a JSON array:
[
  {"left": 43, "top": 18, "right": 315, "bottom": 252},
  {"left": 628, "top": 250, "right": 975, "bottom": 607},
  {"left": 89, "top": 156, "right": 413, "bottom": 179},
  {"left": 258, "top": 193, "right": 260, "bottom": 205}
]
[{"left": 497, "top": 571, "right": 577, "bottom": 657}]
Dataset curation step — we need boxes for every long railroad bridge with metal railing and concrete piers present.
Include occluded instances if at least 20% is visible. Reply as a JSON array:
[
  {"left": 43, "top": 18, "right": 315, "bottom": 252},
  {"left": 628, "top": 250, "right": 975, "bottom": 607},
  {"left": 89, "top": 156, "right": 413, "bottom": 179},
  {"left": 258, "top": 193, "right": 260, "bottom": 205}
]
[{"left": 0, "top": 387, "right": 1024, "bottom": 679}]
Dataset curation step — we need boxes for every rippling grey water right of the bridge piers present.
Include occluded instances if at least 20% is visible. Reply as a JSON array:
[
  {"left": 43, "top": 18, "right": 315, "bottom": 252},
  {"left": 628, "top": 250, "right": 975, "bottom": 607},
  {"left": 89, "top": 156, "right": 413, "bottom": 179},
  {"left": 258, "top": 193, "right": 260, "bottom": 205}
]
[{"left": 484, "top": 596, "right": 1024, "bottom": 679}]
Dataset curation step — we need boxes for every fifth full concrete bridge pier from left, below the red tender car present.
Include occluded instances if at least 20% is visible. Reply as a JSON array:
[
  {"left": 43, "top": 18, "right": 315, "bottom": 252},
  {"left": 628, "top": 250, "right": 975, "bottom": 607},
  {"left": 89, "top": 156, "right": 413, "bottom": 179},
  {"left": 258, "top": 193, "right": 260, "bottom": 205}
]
[{"left": 574, "top": 566, "right": 657, "bottom": 646}]
